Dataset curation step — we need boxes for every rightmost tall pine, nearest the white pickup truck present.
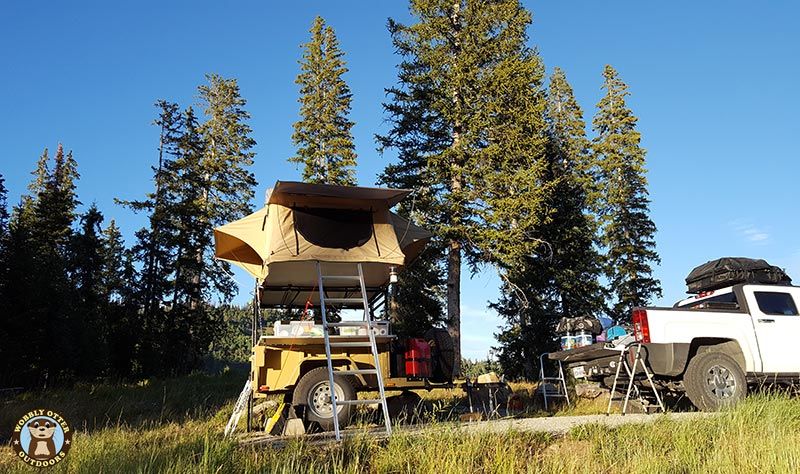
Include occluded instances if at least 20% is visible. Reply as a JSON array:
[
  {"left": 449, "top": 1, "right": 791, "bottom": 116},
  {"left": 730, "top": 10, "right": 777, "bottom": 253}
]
[{"left": 593, "top": 65, "right": 661, "bottom": 321}]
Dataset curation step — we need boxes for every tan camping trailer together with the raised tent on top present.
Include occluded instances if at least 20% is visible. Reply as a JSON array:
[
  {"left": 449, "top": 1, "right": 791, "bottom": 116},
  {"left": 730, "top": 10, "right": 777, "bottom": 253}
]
[{"left": 214, "top": 181, "right": 494, "bottom": 439}]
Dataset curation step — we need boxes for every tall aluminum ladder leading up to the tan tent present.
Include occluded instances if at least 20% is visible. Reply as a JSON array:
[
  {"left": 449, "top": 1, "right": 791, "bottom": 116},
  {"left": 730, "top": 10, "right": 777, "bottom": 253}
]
[{"left": 317, "top": 262, "right": 392, "bottom": 441}]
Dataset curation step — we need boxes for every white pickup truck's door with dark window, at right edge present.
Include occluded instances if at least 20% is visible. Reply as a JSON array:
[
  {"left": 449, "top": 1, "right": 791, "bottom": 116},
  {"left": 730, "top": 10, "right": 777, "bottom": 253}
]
[{"left": 747, "top": 287, "right": 800, "bottom": 374}]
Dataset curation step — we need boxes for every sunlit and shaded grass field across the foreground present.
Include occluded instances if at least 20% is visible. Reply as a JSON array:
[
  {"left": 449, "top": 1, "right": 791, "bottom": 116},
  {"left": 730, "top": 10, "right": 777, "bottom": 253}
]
[{"left": 0, "top": 373, "right": 800, "bottom": 474}]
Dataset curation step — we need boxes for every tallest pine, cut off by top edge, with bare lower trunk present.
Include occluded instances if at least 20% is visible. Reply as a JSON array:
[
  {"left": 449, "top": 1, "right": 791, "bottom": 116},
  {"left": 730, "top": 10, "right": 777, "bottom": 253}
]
[{"left": 379, "top": 0, "right": 544, "bottom": 372}]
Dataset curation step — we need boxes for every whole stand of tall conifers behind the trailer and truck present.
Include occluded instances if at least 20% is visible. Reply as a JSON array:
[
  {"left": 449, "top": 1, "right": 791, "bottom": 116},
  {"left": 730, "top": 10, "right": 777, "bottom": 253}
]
[{"left": 0, "top": 0, "right": 661, "bottom": 388}]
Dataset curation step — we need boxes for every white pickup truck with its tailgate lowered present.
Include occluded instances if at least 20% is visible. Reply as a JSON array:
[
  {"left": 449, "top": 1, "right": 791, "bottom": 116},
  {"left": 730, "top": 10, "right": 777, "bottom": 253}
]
[{"left": 562, "top": 284, "right": 800, "bottom": 411}]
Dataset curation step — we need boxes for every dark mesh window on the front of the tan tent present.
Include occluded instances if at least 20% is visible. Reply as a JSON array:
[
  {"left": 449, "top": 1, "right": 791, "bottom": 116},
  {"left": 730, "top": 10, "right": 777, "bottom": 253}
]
[{"left": 292, "top": 207, "right": 372, "bottom": 250}]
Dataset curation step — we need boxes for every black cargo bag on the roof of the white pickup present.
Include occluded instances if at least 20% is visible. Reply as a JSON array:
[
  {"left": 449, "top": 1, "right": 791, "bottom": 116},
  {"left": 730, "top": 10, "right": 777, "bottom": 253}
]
[{"left": 686, "top": 257, "right": 792, "bottom": 293}]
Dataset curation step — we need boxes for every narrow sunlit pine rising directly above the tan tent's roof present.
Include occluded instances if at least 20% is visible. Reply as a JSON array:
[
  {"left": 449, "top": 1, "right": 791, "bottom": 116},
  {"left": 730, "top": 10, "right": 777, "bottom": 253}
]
[{"left": 289, "top": 16, "right": 356, "bottom": 185}]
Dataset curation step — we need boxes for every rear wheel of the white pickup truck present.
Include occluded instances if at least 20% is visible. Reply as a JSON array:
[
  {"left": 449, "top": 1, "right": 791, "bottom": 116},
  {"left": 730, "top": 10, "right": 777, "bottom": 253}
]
[{"left": 683, "top": 351, "right": 747, "bottom": 411}]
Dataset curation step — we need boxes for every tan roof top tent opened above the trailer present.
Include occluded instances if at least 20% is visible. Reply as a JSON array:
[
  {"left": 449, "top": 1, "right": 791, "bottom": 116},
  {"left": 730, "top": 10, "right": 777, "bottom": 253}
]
[{"left": 214, "top": 181, "right": 433, "bottom": 307}]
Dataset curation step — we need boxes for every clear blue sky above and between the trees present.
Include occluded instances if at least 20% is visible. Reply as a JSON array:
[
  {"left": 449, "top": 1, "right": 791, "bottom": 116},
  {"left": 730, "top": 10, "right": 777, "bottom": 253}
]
[{"left": 0, "top": 1, "right": 800, "bottom": 357}]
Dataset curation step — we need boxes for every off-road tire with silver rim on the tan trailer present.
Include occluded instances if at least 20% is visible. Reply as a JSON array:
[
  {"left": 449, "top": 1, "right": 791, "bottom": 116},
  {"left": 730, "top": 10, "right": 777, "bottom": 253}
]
[{"left": 292, "top": 367, "right": 356, "bottom": 431}]
